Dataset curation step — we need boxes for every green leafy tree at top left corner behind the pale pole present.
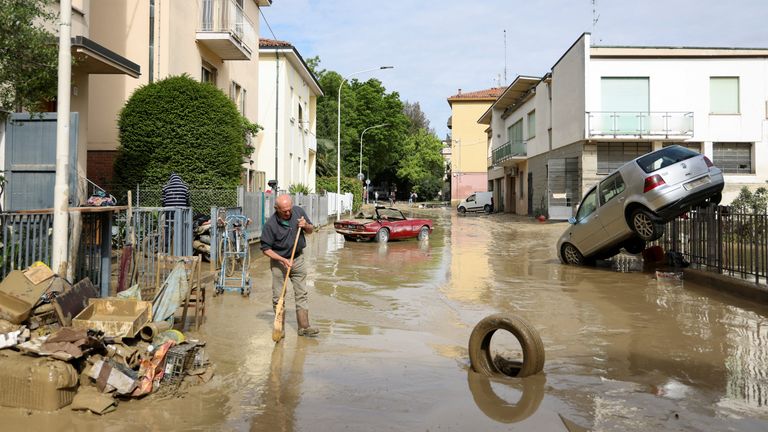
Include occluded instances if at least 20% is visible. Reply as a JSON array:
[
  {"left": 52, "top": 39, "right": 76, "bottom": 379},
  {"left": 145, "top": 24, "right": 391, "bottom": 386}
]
[{"left": 0, "top": 0, "right": 58, "bottom": 112}]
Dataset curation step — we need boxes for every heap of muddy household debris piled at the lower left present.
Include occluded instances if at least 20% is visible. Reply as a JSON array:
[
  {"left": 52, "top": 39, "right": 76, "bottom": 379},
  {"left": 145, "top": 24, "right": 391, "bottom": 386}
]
[{"left": 0, "top": 263, "right": 213, "bottom": 414}]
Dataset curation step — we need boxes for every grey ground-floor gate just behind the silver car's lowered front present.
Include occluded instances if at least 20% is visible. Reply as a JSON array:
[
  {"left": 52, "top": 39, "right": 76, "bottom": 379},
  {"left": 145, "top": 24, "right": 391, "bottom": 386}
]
[{"left": 547, "top": 158, "right": 581, "bottom": 220}]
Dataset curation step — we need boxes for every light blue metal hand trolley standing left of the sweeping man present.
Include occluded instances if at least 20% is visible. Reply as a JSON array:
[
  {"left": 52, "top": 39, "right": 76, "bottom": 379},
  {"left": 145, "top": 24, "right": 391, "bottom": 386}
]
[{"left": 216, "top": 215, "right": 251, "bottom": 296}]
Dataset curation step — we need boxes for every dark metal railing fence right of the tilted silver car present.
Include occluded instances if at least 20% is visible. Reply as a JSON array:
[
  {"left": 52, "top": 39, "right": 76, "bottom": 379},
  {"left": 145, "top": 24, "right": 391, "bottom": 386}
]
[{"left": 659, "top": 206, "right": 768, "bottom": 284}]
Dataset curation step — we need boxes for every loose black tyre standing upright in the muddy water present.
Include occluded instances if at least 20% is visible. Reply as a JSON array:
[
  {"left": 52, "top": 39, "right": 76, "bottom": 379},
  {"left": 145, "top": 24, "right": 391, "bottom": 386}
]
[{"left": 469, "top": 314, "right": 545, "bottom": 378}]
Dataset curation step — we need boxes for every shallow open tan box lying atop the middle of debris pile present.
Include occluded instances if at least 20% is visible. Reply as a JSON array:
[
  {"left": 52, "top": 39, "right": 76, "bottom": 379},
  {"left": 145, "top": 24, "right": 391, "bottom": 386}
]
[{"left": 72, "top": 298, "right": 152, "bottom": 337}]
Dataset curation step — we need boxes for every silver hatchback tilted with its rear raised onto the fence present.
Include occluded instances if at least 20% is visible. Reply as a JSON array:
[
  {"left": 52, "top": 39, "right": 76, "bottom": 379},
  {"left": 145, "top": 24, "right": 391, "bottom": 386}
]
[{"left": 557, "top": 145, "right": 724, "bottom": 264}]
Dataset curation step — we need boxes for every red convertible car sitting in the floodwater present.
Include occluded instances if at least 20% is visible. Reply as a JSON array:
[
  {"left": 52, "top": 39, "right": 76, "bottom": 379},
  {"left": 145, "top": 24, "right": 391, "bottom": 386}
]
[{"left": 333, "top": 207, "right": 432, "bottom": 243}]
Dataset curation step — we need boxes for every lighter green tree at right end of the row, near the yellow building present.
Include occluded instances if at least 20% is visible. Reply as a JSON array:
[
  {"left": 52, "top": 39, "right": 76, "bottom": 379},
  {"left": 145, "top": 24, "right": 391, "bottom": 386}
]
[{"left": 397, "top": 129, "right": 445, "bottom": 199}]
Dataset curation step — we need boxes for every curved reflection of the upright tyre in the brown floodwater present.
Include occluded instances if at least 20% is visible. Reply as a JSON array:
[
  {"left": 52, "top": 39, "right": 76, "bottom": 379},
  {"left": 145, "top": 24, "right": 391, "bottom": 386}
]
[{"left": 467, "top": 369, "right": 547, "bottom": 423}]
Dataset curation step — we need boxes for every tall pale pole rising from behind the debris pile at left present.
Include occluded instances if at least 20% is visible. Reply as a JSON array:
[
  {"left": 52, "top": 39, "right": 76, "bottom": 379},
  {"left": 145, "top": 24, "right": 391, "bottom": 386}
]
[{"left": 51, "top": 0, "right": 72, "bottom": 278}]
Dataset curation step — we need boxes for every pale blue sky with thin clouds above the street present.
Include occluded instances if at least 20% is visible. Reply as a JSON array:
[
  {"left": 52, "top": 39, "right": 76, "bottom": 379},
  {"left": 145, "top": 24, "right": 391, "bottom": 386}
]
[{"left": 259, "top": 0, "right": 768, "bottom": 138}]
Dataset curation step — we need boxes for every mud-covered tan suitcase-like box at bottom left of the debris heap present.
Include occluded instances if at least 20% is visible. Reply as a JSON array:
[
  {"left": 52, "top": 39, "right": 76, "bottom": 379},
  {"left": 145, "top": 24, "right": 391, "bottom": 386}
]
[{"left": 0, "top": 350, "right": 78, "bottom": 411}]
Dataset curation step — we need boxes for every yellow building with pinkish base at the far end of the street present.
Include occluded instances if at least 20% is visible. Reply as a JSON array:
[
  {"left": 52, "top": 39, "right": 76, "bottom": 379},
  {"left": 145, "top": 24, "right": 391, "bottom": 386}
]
[{"left": 448, "top": 87, "right": 504, "bottom": 205}]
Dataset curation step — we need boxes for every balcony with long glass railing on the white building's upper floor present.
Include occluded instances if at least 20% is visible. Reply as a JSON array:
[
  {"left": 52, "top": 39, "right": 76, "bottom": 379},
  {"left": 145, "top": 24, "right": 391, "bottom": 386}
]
[{"left": 586, "top": 111, "right": 693, "bottom": 139}]
